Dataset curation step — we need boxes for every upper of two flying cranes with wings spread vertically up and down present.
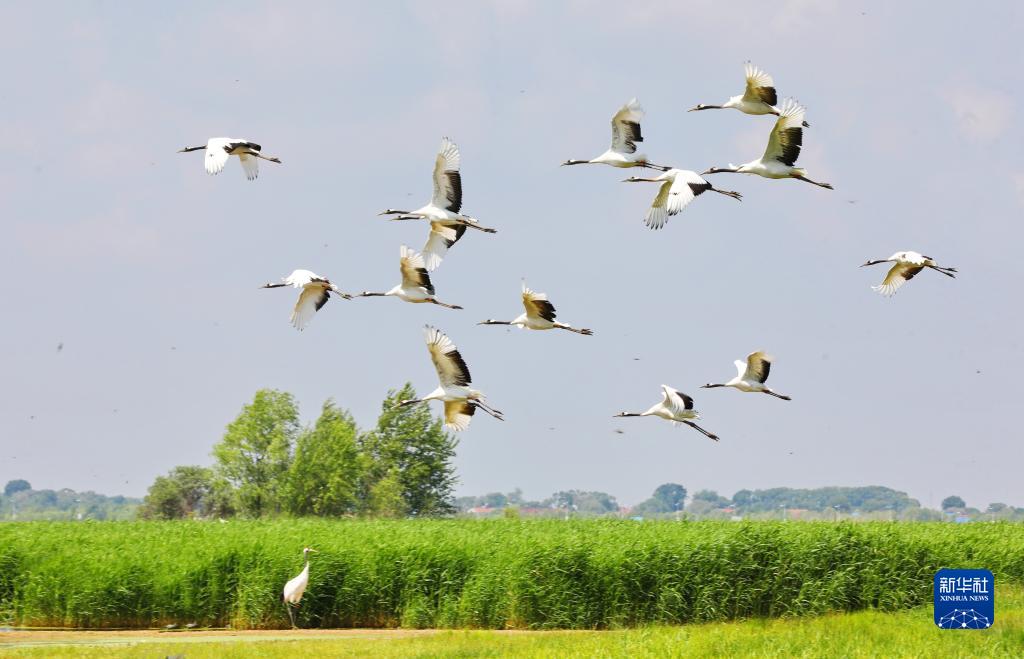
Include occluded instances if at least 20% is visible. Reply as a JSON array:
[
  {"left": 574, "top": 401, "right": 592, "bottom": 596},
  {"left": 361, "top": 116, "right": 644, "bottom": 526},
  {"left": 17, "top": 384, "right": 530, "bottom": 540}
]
[{"left": 379, "top": 137, "right": 498, "bottom": 272}]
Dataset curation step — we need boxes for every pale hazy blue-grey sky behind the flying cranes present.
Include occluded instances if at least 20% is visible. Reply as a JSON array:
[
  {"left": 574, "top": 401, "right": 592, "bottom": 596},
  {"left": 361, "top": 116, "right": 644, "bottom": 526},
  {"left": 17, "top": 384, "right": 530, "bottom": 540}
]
[{"left": 0, "top": 0, "right": 1024, "bottom": 507}]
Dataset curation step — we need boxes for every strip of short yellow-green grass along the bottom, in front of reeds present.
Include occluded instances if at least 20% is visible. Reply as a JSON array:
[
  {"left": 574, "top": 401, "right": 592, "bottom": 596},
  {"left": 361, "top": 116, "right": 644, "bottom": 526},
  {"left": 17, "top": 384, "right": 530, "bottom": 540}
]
[{"left": 8, "top": 585, "right": 1024, "bottom": 659}]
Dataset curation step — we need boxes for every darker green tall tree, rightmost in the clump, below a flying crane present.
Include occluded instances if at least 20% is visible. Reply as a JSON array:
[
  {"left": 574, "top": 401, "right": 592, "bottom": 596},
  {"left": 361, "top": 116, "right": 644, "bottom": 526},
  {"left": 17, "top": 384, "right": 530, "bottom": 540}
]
[{"left": 359, "top": 383, "right": 457, "bottom": 516}]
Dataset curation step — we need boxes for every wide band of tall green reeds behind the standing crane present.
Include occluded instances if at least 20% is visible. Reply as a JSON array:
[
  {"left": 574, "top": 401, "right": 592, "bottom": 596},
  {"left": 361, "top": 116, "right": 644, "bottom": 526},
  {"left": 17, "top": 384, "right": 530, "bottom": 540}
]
[{"left": 0, "top": 520, "right": 1024, "bottom": 629}]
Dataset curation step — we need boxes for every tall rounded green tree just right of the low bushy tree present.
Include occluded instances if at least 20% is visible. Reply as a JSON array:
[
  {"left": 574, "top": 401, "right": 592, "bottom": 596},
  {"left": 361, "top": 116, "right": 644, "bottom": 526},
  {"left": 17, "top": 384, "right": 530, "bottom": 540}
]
[{"left": 213, "top": 389, "right": 299, "bottom": 517}]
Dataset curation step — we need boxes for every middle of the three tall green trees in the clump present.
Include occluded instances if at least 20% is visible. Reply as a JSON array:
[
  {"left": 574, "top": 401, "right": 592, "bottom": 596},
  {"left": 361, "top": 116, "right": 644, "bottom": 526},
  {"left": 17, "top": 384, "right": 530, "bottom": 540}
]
[{"left": 287, "top": 400, "right": 366, "bottom": 516}]
